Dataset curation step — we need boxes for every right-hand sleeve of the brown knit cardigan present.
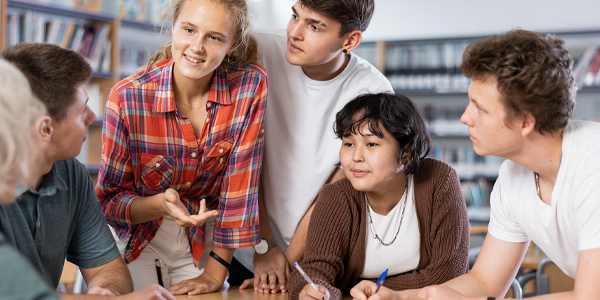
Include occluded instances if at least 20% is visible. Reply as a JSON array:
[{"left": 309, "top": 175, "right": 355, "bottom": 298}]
[{"left": 384, "top": 165, "right": 469, "bottom": 290}]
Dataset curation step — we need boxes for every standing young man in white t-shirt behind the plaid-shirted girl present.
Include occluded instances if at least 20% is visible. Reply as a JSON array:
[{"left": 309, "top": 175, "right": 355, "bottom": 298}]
[{"left": 232, "top": 0, "right": 393, "bottom": 293}]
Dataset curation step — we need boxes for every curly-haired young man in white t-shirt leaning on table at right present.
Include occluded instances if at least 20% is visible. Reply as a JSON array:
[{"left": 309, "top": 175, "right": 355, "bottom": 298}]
[{"left": 351, "top": 30, "right": 600, "bottom": 300}]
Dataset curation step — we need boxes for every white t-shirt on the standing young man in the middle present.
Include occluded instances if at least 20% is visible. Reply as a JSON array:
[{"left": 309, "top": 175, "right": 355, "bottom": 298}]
[{"left": 235, "top": 29, "right": 393, "bottom": 270}]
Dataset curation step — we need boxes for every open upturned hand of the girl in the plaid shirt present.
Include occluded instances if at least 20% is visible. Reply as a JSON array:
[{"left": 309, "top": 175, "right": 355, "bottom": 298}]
[{"left": 164, "top": 189, "right": 217, "bottom": 227}]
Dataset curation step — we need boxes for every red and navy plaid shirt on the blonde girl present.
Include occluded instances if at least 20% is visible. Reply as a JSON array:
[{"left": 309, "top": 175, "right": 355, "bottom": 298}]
[{"left": 96, "top": 59, "right": 267, "bottom": 264}]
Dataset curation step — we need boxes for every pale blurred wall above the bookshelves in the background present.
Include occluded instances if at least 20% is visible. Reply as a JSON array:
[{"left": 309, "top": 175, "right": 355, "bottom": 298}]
[{"left": 249, "top": 0, "right": 600, "bottom": 41}]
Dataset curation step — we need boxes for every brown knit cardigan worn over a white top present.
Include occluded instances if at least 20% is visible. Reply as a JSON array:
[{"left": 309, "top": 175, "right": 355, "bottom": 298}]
[{"left": 289, "top": 158, "right": 469, "bottom": 300}]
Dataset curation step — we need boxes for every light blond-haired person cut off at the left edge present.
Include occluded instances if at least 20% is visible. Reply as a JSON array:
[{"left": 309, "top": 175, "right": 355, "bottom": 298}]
[{"left": 0, "top": 59, "right": 59, "bottom": 300}]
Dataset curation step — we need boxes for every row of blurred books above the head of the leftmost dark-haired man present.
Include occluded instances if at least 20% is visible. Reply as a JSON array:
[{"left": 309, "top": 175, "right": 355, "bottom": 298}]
[{"left": 7, "top": 10, "right": 111, "bottom": 72}]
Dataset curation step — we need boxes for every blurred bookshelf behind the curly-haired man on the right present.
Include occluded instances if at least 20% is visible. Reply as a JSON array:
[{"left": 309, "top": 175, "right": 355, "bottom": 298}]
[{"left": 355, "top": 28, "right": 600, "bottom": 221}]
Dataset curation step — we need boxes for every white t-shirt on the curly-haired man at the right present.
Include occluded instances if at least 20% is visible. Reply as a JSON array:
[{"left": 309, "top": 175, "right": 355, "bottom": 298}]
[{"left": 488, "top": 121, "right": 600, "bottom": 278}]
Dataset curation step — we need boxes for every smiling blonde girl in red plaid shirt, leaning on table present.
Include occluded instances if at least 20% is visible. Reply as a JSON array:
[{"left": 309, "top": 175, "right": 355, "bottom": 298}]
[{"left": 96, "top": 0, "right": 267, "bottom": 294}]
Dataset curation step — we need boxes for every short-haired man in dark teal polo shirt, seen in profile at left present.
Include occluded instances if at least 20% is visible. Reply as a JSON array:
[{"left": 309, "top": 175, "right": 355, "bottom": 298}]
[{"left": 0, "top": 44, "right": 175, "bottom": 299}]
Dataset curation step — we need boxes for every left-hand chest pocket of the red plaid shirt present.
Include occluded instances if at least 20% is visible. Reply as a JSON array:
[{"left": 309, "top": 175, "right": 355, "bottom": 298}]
[{"left": 141, "top": 153, "right": 173, "bottom": 192}]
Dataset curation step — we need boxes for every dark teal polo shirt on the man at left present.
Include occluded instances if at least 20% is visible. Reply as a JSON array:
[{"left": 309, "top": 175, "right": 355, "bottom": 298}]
[{"left": 0, "top": 158, "right": 119, "bottom": 288}]
